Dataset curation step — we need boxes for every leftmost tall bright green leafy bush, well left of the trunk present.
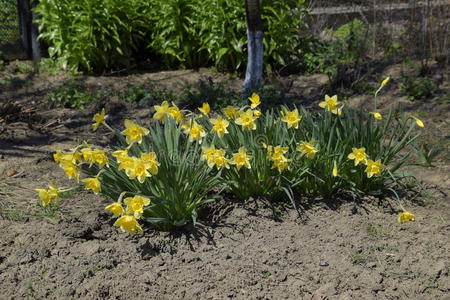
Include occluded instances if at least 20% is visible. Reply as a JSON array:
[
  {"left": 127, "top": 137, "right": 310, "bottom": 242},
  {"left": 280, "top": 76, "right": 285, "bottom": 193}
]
[{"left": 35, "top": 0, "right": 149, "bottom": 71}]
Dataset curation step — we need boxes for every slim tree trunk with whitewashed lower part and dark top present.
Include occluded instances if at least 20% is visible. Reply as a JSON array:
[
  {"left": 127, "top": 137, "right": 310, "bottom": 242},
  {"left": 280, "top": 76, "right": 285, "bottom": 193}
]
[{"left": 242, "top": 0, "right": 264, "bottom": 90}]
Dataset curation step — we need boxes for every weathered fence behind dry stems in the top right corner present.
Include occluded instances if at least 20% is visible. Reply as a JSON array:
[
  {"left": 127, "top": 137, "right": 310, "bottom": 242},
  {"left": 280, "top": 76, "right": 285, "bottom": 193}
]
[{"left": 308, "top": 0, "right": 450, "bottom": 65}]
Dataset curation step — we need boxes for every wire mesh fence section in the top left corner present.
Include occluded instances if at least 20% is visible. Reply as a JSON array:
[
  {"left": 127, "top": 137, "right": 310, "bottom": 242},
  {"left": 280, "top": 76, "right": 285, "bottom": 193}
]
[{"left": 0, "top": 0, "right": 26, "bottom": 59}]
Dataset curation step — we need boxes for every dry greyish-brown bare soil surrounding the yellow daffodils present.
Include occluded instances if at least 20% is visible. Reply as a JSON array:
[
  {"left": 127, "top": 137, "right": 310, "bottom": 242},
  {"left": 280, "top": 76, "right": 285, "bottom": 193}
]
[{"left": 0, "top": 65, "right": 450, "bottom": 299}]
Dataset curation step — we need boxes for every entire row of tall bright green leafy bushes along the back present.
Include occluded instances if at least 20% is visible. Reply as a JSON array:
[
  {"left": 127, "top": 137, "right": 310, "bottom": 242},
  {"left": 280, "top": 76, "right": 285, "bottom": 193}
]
[{"left": 35, "top": 0, "right": 306, "bottom": 72}]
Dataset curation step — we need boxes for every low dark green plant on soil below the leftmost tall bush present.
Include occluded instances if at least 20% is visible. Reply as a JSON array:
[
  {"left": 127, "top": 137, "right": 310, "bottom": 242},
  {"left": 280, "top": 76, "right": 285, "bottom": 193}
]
[{"left": 44, "top": 79, "right": 100, "bottom": 109}]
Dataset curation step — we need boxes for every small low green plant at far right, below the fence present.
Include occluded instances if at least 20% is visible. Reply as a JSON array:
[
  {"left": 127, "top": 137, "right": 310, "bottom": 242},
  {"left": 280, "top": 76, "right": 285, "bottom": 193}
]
[{"left": 400, "top": 76, "right": 438, "bottom": 101}]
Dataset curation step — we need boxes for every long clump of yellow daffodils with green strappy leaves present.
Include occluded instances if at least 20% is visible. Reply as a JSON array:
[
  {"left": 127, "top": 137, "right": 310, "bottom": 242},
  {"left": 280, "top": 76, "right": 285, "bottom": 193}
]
[{"left": 36, "top": 90, "right": 424, "bottom": 234}]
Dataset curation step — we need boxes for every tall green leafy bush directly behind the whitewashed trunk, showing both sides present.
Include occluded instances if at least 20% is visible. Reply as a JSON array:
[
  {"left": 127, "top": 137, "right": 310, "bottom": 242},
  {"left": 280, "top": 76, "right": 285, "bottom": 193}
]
[{"left": 150, "top": 0, "right": 306, "bottom": 71}]
